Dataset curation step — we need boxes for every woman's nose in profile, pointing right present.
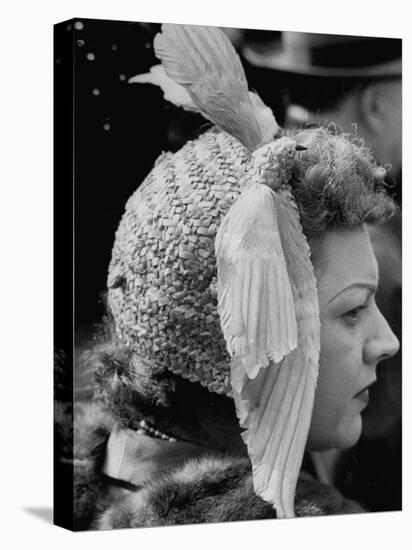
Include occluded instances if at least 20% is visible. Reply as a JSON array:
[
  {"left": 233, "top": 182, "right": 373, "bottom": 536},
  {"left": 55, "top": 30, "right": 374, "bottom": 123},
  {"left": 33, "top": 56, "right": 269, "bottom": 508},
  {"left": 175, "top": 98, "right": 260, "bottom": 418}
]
[{"left": 364, "top": 307, "right": 399, "bottom": 365}]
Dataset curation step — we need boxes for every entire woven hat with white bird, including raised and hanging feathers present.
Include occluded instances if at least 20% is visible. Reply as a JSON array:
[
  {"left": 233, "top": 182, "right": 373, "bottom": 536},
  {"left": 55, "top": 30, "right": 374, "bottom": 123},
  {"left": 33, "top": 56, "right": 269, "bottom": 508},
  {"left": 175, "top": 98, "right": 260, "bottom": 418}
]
[{"left": 108, "top": 25, "right": 319, "bottom": 517}]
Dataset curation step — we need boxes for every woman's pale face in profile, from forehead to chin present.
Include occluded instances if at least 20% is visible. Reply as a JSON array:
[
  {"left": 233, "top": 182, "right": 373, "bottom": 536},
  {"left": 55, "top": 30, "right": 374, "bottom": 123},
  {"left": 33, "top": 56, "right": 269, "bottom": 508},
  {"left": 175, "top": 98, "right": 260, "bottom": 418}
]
[{"left": 308, "top": 226, "right": 399, "bottom": 450}]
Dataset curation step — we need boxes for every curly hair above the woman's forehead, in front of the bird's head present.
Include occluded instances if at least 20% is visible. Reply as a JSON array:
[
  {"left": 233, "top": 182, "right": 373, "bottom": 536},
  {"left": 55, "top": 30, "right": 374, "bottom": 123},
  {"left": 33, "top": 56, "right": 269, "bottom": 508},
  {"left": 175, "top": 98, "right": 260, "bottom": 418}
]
[{"left": 290, "top": 126, "right": 396, "bottom": 242}]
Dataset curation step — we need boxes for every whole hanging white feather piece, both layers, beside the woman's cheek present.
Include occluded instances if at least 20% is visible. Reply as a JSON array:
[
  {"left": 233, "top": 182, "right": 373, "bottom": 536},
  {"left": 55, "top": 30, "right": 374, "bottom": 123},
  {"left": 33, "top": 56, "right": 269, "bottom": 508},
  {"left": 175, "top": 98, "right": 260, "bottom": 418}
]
[{"left": 216, "top": 183, "right": 320, "bottom": 517}]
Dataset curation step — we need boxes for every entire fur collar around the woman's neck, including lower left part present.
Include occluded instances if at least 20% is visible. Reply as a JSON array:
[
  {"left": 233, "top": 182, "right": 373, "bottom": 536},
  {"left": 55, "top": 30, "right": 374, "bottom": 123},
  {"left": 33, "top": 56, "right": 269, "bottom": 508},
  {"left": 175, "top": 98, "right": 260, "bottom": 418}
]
[{"left": 60, "top": 404, "right": 364, "bottom": 530}]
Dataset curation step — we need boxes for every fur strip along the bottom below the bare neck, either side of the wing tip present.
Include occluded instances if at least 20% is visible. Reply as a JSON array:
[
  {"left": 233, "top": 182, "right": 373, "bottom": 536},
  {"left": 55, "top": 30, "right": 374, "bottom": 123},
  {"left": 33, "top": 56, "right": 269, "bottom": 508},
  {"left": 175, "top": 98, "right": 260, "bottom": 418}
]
[{"left": 94, "top": 457, "right": 364, "bottom": 529}]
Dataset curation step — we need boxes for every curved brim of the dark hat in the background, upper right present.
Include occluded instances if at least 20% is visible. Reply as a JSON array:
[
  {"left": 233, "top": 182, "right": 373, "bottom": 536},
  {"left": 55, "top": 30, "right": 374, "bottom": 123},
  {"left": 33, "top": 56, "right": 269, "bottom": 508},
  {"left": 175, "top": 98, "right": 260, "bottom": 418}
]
[{"left": 242, "top": 46, "right": 402, "bottom": 78}]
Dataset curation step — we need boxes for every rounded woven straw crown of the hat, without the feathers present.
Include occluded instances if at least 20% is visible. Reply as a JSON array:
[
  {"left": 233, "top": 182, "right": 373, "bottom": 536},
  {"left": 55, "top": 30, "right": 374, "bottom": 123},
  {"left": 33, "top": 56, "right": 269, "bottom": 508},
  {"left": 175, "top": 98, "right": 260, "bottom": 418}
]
[{"left": 108, "top": 129, "right": 251, "bottom": 395}]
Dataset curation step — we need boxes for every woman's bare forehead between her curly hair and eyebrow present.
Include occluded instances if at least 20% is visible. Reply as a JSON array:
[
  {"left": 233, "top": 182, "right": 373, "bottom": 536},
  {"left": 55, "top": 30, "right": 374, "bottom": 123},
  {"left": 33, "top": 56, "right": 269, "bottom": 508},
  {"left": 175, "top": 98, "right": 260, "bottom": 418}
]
[{"left": 315, "top": 226, "right": 378, "bottom": 304}]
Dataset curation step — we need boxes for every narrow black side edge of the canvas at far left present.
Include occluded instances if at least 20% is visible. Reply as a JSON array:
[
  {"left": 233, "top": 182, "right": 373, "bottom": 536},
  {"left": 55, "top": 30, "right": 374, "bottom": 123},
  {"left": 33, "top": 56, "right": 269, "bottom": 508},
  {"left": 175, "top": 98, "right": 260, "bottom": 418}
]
[{"left": 53, "top": 19, "right": 75, "bottom": 530}]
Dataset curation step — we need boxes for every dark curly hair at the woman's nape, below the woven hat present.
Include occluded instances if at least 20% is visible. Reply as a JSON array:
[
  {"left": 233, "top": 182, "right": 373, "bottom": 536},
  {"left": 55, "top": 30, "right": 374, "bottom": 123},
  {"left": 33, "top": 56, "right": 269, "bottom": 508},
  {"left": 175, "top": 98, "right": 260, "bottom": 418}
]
[{"left": 88, "top": 332, "right": 236, "bottom": 440}]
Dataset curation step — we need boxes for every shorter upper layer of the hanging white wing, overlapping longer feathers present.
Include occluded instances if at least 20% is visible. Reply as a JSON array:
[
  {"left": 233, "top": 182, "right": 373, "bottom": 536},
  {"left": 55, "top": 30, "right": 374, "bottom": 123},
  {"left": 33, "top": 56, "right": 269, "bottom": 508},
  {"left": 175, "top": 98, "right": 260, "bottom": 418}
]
[{"left": 216, "top": 183, "right": 297, "bottom": 378}]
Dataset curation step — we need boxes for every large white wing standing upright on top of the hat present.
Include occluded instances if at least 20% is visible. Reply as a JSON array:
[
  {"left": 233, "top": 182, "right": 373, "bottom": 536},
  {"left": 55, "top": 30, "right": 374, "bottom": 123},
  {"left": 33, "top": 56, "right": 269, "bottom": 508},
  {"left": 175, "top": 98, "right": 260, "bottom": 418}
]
[{"left": 154, "top": 24, "right": 279, "bottom": 151}]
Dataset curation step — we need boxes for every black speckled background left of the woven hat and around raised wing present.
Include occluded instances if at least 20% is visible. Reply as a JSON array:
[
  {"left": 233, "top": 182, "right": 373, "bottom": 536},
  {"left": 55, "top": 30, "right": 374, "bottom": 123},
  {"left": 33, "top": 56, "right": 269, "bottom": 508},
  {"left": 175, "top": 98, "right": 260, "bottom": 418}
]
[{"left": 62, "top": 19, "right": 283, "bottom": 336}]
